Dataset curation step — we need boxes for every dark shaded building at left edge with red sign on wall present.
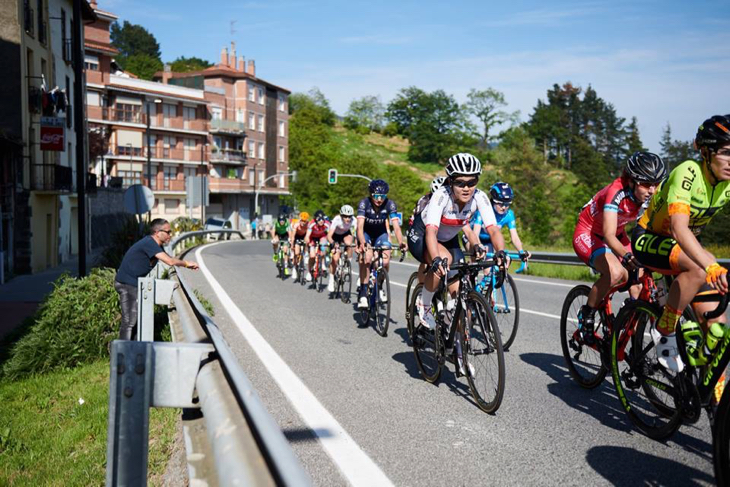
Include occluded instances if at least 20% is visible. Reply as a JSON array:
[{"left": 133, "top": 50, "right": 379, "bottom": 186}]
[{"left": 0, "top": 0, "right": 95, "bottom": 274}]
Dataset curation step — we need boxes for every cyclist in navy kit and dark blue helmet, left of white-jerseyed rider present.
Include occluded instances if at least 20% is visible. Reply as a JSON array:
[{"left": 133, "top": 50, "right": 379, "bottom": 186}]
[{"left": 357, "top": 179, "right": 406, "bottom": 309}]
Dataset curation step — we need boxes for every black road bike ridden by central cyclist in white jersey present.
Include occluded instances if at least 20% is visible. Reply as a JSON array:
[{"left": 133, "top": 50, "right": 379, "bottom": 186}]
[{"left": 409, "top": 261, "right": 505, "bottom": 414}]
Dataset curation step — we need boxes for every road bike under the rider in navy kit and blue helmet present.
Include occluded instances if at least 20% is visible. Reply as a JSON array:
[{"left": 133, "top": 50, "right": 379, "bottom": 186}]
[{"left": 360, "top": 246, "right": 396, "bottom": 337}]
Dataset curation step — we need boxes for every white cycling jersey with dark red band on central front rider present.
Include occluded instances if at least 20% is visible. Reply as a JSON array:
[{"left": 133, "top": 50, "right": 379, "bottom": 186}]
[{"left": 421, "top": 186, "right": 497, "bottom": 242}]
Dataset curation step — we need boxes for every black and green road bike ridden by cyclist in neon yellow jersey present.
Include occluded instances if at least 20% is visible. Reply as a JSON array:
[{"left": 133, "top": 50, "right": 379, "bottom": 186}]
[{"left": 611, "top": 282, "right": 730, "bottom": 442}]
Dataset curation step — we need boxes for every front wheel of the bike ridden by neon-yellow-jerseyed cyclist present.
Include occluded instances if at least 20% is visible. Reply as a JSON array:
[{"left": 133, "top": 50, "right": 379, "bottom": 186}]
[{"left": 611, "top": 300, "right": 682, "bottom": 440}]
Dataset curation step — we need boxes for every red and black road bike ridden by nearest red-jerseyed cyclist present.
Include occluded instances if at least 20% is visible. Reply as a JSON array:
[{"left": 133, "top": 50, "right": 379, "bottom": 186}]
[{"left": 560, "top": 271, "right": 659, "bottom": 389}]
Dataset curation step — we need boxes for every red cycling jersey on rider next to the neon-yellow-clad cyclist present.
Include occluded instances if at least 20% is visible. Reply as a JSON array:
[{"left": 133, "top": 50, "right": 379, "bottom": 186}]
[{"left": 576, "top": 177, "right": 642, "bottom": 237}]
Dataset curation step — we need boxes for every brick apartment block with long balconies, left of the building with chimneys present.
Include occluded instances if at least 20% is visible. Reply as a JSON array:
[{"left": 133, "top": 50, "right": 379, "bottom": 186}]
[{"left": 84, "top": 2, "right": 210, "bottom": 220}]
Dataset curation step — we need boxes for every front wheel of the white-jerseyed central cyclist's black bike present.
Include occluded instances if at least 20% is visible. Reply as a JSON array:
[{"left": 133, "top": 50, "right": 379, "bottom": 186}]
[{"left": 460, "top": 291, "right": 505, "bottom": 414}]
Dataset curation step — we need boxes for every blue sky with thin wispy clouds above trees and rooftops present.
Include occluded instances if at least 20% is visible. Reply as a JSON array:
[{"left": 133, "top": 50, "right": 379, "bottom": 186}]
[{"left": 99, "top": 0, "right": 730, "bottom": 151}]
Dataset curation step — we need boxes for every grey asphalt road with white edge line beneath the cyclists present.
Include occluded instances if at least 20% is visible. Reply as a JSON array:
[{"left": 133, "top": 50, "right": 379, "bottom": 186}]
[{"left": 183, "top": 241, "right": 714, "bottom": 486}]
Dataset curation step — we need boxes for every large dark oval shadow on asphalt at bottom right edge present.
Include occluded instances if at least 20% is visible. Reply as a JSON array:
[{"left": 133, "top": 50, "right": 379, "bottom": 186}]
[{"left": 586, "top": 446, "right": 715, "bottom": 487}]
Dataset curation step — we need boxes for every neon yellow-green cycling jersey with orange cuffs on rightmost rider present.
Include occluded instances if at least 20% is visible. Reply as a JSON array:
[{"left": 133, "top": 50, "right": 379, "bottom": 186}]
[{"left": 639, "top": 160, "right": 730, "bottom": 236}]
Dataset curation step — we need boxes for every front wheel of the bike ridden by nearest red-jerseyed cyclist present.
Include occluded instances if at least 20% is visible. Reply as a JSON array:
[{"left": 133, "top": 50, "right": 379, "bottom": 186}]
[{"left": 560, "top": 285, "right": 610, "bottom": 389}]
